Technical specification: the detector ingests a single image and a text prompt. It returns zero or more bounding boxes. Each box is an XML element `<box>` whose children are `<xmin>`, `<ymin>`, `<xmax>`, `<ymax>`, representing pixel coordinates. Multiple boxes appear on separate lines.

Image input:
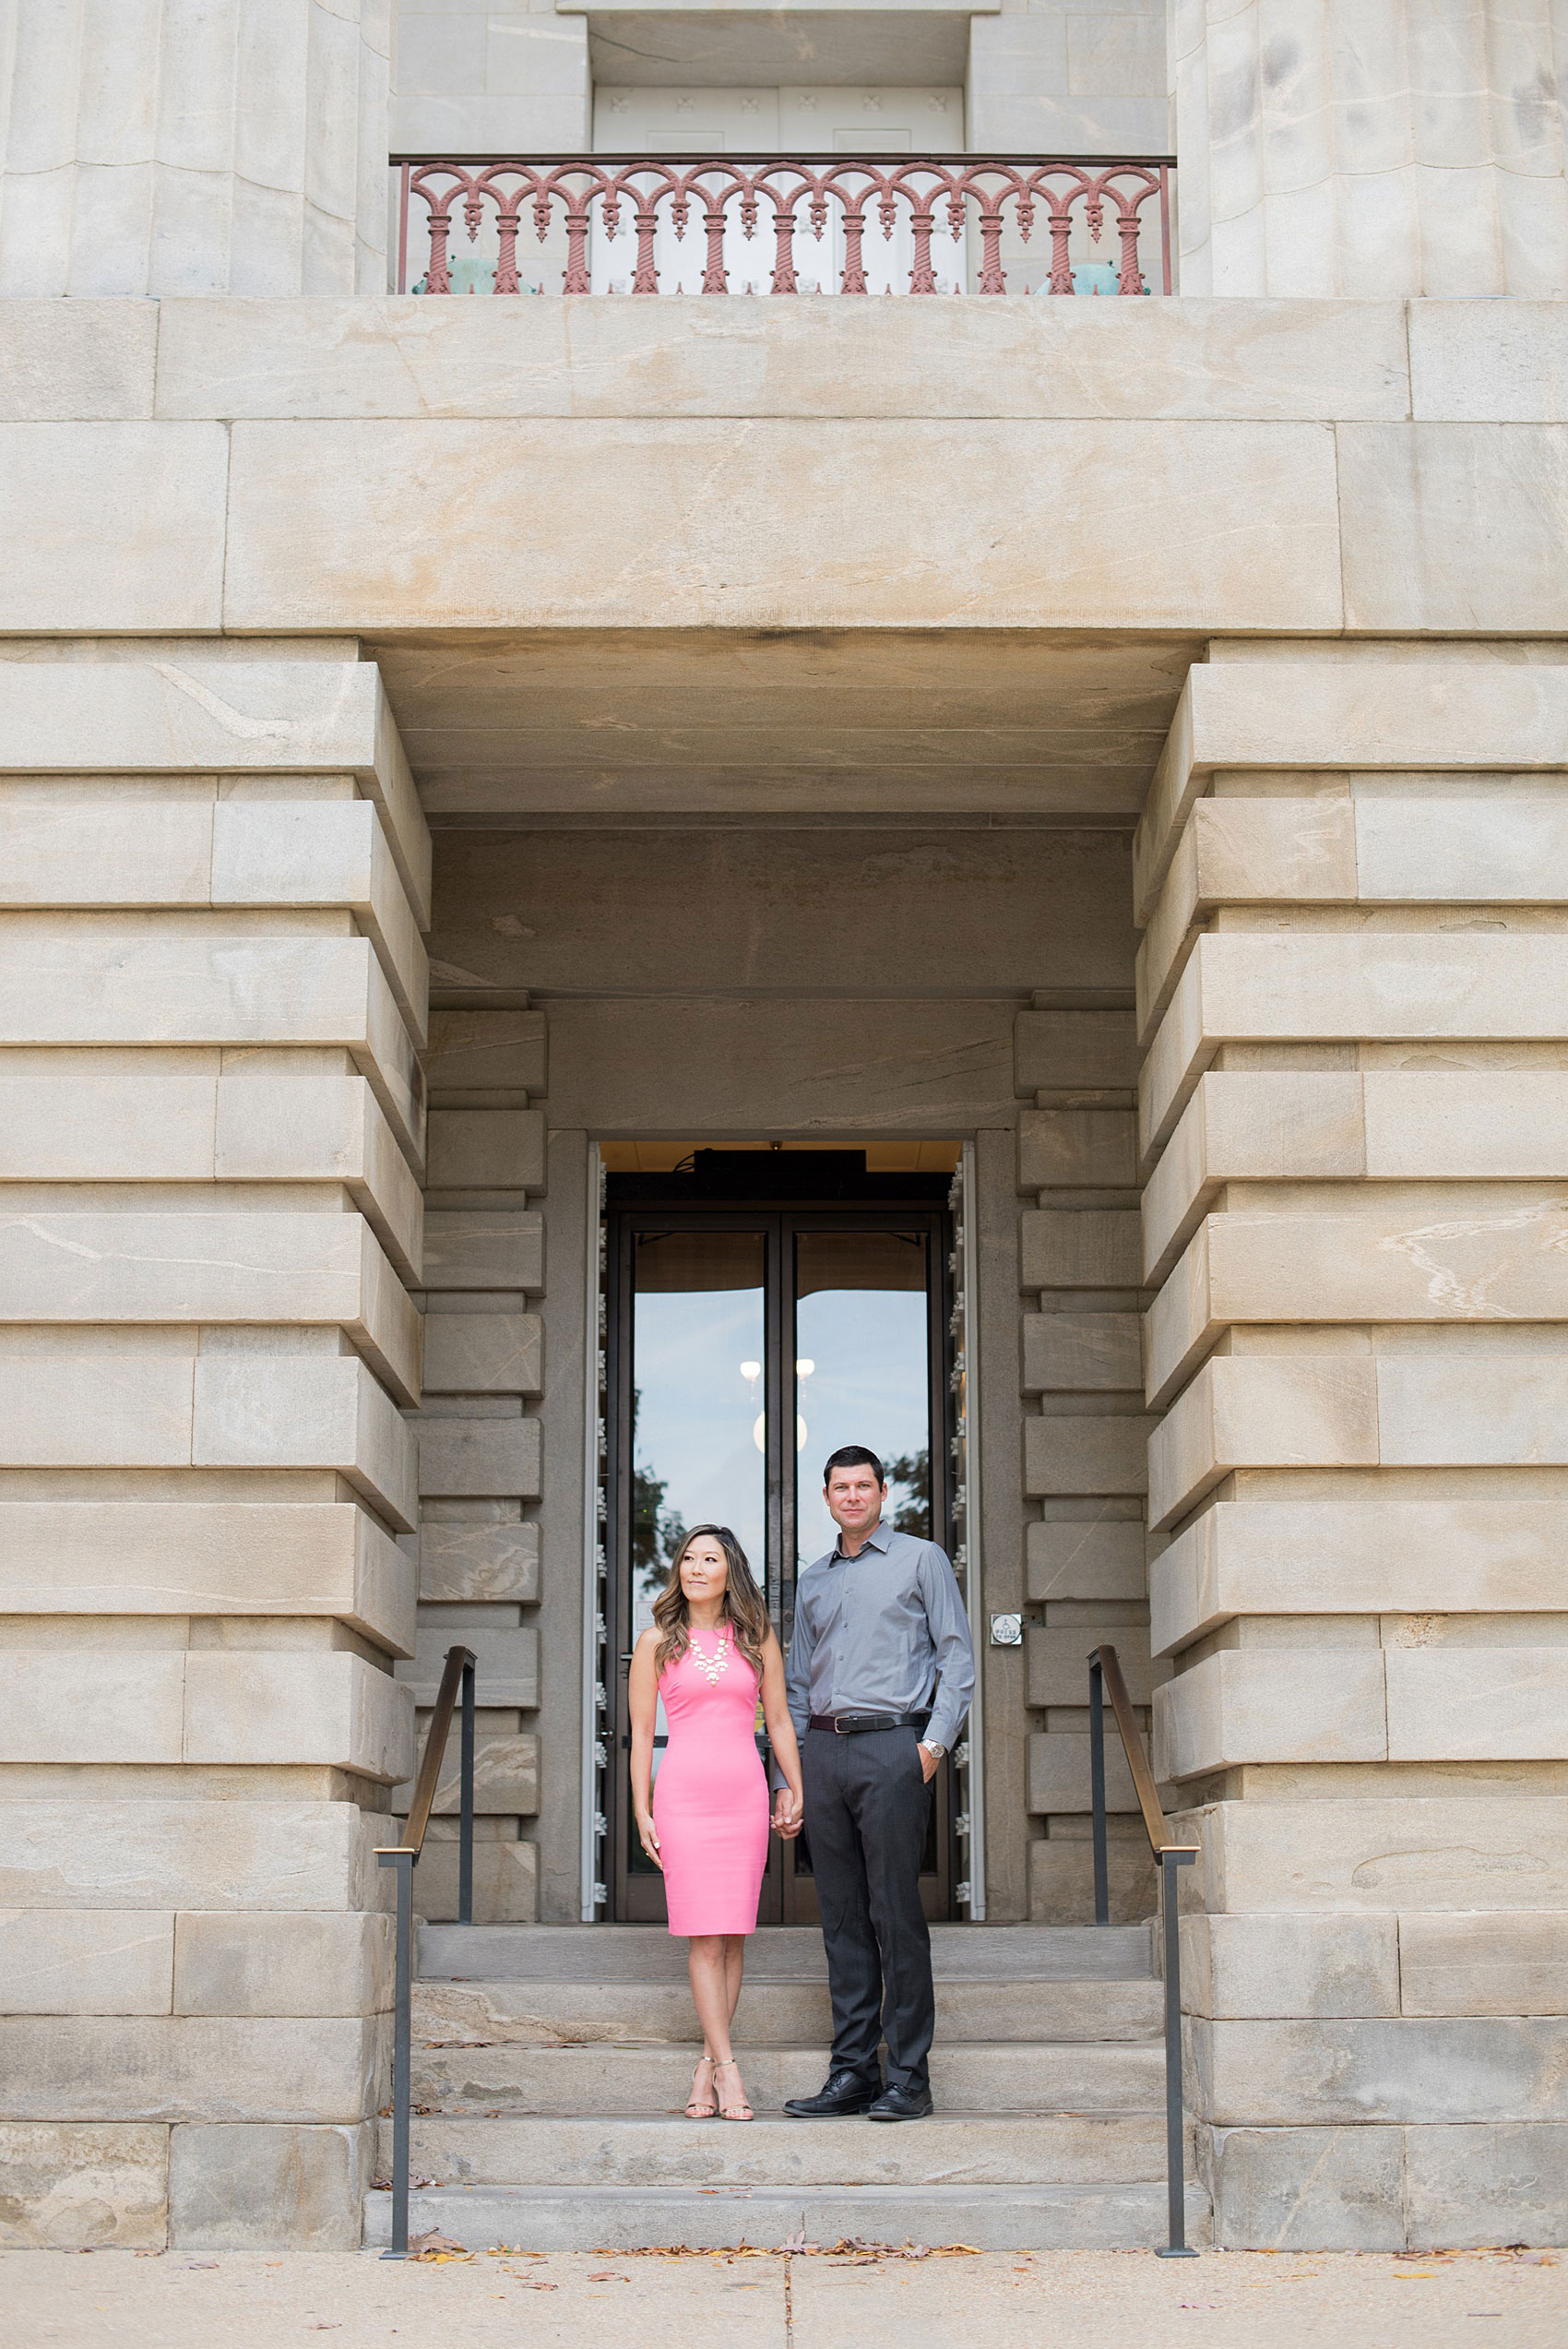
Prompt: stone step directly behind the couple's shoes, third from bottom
<box><xmin>413</xmin><ymin>2041</ymin><xmax>1164</xmax><ymax>2135</ymax></box>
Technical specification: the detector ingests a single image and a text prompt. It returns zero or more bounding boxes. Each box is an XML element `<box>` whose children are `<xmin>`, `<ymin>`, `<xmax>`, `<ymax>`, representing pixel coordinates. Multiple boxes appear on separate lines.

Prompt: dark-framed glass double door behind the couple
<box><xmin>608</xmin><ymin>1200</ymin><xmax>951</xmax><ymax>1924</ymax></box>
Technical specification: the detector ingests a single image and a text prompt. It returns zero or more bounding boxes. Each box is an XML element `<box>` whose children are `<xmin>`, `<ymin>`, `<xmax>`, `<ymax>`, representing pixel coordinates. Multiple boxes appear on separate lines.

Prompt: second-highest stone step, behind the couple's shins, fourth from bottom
<box><xmin>413</xmin><ymin>1978</ymin><xmax>1164</xmax><ymax>2048</ymax></box>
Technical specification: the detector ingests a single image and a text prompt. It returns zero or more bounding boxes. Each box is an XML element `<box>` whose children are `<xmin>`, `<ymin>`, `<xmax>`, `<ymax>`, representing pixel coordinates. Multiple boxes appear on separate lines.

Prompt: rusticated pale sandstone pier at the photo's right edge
<box><xmin>1136</xmin><ymin>644</ymin><xmax>1568</xmax><ymax>2248</ymax></box>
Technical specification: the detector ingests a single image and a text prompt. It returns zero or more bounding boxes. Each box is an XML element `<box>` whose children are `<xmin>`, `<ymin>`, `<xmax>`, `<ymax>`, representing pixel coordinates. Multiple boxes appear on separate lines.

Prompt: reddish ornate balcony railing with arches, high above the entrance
<box><xmin>392</xmin><ymin>155</ymin><xmax>1173</xmax><ymax>298</ymax></box>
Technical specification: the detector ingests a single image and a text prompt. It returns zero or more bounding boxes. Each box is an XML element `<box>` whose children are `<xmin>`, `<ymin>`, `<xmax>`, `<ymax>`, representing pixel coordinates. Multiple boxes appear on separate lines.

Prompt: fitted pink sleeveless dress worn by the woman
<box><xmin>652</xmin><ymin>1632</ymin><xmax>767</xmax><ymax>1933</ymax></box>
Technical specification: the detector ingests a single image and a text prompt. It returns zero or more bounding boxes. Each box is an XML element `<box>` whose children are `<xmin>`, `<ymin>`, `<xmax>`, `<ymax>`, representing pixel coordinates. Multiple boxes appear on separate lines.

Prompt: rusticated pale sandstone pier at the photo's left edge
<box><xmin>0</xmin><ymin>646</ymin><xmax>430</xmax><ymax>2248</ymax></box>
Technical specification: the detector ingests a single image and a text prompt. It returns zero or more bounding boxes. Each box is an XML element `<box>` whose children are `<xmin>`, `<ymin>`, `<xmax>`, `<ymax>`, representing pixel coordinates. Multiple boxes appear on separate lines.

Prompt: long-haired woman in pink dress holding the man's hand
<box><xmin>629</xmin><ymin>1524</ymin><xmax>802</xmax><ymax>2121</ymax></box>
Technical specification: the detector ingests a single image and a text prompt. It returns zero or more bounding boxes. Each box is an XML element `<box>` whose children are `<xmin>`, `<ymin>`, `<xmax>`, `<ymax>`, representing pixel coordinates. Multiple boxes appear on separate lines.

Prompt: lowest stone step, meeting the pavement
<box><xmin>366</xmin><ymin>2170</ymin><xmax>1209</xmax><ymax>2250</ymax></box>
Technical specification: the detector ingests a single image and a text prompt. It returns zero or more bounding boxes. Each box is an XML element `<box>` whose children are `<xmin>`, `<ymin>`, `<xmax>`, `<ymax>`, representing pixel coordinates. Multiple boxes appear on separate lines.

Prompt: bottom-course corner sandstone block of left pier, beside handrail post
<box><xmin>169</xmin><ymin>2121</ymin><xmax>374</xmax><ymax>2250</ymax></box>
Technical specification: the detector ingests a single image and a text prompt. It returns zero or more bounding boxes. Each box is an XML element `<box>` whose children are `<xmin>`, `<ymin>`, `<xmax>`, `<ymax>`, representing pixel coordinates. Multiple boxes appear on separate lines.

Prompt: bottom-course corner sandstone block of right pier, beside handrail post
<box><xmin>1211</xmin><ymin>2126</ymin><xmax>1404</xmax><ymax>2250</ymax></box>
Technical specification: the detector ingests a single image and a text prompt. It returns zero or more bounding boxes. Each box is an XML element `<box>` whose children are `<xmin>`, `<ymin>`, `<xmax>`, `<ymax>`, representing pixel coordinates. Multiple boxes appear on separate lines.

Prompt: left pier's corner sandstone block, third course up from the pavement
<box><xmin>173</xmin><ymin>1910</ymin><xmax>392</xmax><ymax>2015</ymax></box>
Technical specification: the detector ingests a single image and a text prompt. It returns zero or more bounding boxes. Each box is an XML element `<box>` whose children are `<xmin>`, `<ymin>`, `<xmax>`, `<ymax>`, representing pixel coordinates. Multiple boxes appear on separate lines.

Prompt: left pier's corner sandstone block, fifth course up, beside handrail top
<box><xmin>184</xmin><ymin>1649</ymin><xmax>413</xmax><ymax>1783</ymax></box>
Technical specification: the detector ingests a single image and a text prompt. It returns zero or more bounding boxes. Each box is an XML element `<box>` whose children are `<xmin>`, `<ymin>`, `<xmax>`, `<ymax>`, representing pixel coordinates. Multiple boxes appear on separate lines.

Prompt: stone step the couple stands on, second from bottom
<box><xmin>375</xmin><ymin>2109</ymin><xmax>1182</xmax><ymax>2189</ymax></box>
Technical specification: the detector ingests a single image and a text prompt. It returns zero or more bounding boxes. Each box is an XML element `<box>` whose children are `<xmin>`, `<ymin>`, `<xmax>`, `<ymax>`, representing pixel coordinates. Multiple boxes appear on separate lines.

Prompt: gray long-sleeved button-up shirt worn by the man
<box><xmin>784</xmin><ymin>1524</ymin><xmax>974</xmax><ymax>1746</ymax></box>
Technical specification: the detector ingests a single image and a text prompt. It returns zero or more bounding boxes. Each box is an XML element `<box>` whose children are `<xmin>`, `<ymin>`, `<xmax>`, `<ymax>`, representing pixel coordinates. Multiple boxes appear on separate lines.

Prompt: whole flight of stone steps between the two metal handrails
<box><xmin>366</xmin><ymin>1924</ymin><xmax>1209</xmax><ymax>2250</ymax></box>
